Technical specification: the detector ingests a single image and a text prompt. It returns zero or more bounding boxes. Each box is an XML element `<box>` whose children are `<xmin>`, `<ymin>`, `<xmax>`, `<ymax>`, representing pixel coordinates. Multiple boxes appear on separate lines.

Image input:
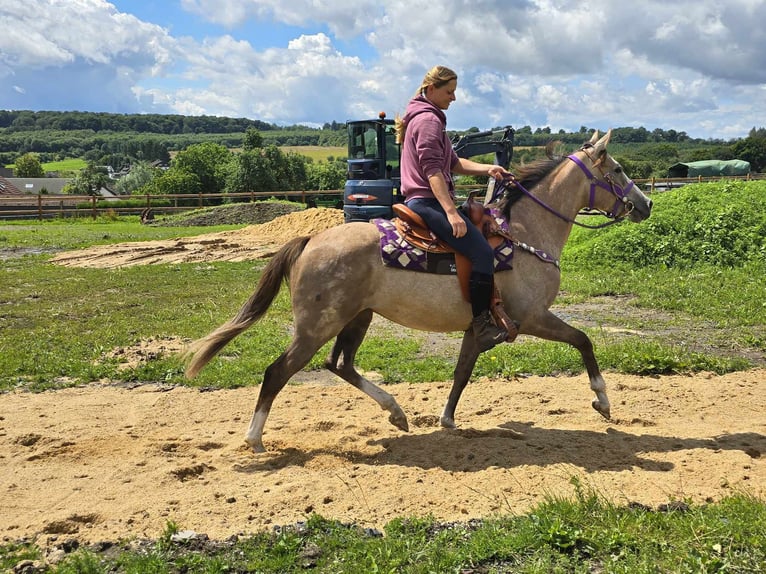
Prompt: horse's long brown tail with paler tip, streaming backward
<box><xmin>184</xmin><ymin>237</ymin><xmax>309</xmax><ymax>378</ymax></box>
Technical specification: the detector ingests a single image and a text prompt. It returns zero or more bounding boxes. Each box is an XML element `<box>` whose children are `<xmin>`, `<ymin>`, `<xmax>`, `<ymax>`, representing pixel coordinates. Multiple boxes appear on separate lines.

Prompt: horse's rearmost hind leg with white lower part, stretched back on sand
<box><xmin>245</xmin><ymin>335</ymin><xmax>325</xmax><ymax>452</ymax></box>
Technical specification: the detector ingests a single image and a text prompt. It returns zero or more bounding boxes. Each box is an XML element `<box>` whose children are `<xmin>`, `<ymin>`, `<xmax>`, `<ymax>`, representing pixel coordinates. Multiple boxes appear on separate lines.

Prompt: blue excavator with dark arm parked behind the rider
<box><xmin>343</xmin><ymin>112</ymin><xmax>514</xmax><ymax>223</ymax></box>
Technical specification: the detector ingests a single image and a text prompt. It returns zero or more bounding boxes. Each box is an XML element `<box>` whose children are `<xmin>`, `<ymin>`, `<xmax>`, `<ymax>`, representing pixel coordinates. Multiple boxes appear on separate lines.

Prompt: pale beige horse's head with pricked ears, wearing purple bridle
<box><xmin>568</xmin><ymin>129</ymin><xmax>652</xmax><ymax>222</ymax></box>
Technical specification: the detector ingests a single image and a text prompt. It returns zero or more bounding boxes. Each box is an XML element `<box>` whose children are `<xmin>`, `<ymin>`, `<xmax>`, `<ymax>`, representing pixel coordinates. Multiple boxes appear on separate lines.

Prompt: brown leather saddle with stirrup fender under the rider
<box><xmin>392</xmin><ymin>196</ymin><xmax>519</xmax><ymax>343</ymax></box>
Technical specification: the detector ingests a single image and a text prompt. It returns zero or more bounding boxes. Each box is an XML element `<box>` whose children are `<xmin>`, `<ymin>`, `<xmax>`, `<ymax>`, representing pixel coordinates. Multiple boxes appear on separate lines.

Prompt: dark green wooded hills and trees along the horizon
<box><xmin>0</xmin><ymin>110</ymin><xmax>766</xmax><ymax>196</ymax></box>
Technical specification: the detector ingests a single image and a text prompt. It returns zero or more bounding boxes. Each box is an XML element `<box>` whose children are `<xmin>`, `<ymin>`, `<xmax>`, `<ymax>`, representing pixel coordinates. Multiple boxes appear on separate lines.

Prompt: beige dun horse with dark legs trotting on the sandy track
<box><xmin>185</xmin><ymin>130</ymin><xmax>652</xmax><ymax>453</ymax></box>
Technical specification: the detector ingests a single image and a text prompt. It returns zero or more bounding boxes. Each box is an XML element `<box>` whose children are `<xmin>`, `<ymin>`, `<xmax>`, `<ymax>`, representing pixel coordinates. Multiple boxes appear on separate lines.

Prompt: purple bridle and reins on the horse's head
<box><xmin>494</xmin><ymin>143</ymin><xmax>635</xmax><ymax>229</ymax></box>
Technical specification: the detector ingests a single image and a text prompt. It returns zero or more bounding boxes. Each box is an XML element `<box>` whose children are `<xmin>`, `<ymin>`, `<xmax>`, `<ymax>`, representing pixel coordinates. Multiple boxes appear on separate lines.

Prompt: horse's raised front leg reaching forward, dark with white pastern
<box><xmin>522</xmin><ymin>311</ymin><xmax>611</xmax><ymax>419</ymax></box>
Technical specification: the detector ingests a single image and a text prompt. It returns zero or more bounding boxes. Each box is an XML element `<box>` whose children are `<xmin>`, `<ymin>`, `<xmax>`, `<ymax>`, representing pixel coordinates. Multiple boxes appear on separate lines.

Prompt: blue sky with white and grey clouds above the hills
<box><xmin>0</xmin><ymin>0</ymin><xmax>766</xmax><ymax>140</ymax></box>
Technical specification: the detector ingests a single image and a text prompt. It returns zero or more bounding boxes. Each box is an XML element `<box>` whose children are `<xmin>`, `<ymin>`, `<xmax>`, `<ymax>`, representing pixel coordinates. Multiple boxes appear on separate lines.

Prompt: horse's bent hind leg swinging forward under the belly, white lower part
<box><xmin>325</xmin><ymin>309</ymin><xmax>409</xmax><ymax>431</ymax></box>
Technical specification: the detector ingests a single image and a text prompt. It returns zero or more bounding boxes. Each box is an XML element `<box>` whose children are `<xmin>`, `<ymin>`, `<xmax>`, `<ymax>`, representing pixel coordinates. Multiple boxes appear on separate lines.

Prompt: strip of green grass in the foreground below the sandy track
<box><xmin>0</xmin><ymin>492</ymin><xmax>766</xmax><ymax>574</ymax></box>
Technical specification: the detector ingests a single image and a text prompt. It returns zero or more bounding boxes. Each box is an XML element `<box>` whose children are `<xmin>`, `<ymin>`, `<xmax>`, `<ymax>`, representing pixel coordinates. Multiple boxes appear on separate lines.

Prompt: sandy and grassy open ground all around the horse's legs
<box><xmin>0</xmin><ymin>183</ymin><xmax>766</xmax><ymax>572</ymax></box>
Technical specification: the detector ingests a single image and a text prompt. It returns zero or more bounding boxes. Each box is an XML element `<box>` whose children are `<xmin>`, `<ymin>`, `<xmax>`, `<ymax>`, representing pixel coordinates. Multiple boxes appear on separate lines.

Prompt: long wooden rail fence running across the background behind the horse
<box><xmin>0</xmin><ymin>173</ymin><xmax>766</xmax><ymax>220</ymax></box>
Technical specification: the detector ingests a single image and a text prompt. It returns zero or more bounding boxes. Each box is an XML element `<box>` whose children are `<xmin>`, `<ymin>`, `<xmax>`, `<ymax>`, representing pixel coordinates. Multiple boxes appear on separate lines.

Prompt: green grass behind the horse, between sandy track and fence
<box><xmin>0</xmin><ymin>182</ymin><xmax>766</xmax><ymax>389</ymax></box>
